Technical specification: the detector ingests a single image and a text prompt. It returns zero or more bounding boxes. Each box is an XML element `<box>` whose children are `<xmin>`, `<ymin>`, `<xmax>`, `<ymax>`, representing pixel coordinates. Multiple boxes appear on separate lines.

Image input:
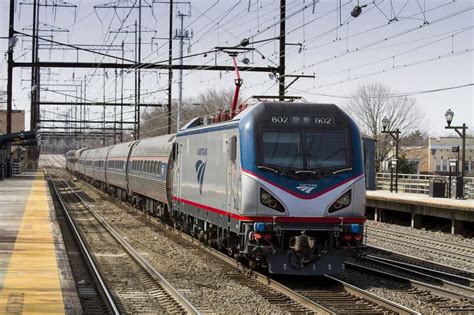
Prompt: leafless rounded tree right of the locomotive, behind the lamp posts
<box><xmin>344</xmin><ymin>83</ymin><xmax>425</xmax><ymax>169</ymax></box>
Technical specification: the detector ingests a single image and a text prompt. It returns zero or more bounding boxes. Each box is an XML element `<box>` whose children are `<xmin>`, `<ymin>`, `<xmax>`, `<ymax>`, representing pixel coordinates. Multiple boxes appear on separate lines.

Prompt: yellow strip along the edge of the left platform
<box><xmin>0</xmin><ymin>172</ymin><xmax>64</xmax><ymax>314</ymax></box>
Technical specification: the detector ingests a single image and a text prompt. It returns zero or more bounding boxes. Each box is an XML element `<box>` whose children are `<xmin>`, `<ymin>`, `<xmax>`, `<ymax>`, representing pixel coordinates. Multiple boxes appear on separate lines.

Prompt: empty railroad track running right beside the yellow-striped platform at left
<box><xmin>46</xmin><ymin>170</ymin><xmax>200</xmax><ymax>314</ymax></box>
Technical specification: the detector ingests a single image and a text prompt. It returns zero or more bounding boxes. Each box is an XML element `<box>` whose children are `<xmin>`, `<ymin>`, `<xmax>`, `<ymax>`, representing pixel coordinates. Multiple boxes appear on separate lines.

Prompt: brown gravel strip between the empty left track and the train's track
<box><xmin>71</xmin><ymin>182</ymin><xmax>284</xmax><ymax>314</ymax></box>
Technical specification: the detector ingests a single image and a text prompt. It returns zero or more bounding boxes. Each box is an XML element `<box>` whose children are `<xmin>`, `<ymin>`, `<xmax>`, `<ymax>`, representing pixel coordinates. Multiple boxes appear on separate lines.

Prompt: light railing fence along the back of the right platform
<box><xmin>377</xmin><ymin>173</ymin><xmax>474</xmax><ymax>199</ymax></box>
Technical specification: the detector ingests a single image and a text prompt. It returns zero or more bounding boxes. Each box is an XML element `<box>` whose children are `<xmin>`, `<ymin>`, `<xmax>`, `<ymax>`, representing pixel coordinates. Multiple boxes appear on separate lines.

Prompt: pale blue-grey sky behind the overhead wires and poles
<box><xmin>0</xmin><ymin>0</ymin><xmax>474</xmax><ymax>136</ymax></box>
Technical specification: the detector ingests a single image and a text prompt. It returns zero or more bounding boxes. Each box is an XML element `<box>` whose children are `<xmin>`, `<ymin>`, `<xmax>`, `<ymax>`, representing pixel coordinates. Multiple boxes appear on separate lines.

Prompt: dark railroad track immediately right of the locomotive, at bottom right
<box><xmin>346</xmin><ymin>259</ymin><xmax>474</xmax><ymax>314</ymax></box>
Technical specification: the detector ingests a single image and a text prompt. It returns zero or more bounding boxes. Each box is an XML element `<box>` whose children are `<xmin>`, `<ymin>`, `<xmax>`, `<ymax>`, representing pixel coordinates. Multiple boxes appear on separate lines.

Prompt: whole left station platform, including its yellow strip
<box><xmin>0</xmin><ymin>171</ymin><xmax>81</xmax><ymax>314</ymax></box>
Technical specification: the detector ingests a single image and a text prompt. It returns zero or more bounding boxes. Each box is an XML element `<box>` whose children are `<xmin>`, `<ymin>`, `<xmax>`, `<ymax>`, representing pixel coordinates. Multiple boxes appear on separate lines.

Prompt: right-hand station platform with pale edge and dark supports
<box><xmin>367</xmin><ymin>190</ymin><xmax>474</xmax><ymax>234</ymax></box>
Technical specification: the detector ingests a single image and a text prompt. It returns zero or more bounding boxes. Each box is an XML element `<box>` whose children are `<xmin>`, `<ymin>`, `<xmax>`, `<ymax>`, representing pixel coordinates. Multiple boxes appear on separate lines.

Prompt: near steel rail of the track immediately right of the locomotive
<box><xmin>346</xmin><ymin>262</ymin><xmax>474</xmax><ymax>301</ymax></box>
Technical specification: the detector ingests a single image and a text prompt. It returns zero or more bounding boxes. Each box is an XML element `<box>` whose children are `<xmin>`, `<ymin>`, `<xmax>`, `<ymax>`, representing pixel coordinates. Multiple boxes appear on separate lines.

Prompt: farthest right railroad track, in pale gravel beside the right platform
<box><xmin>367</xmin><ymin>227</ymin><xmax>474</xmax><ymax>263</ymax></box>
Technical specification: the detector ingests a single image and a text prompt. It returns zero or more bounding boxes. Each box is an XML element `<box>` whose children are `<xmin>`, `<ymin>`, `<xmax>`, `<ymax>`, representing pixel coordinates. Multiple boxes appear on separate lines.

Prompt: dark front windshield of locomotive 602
<box><xmin>260</xmin><ymin>131</ymin><xmax>350</xmax><ymax>171</ymax></box>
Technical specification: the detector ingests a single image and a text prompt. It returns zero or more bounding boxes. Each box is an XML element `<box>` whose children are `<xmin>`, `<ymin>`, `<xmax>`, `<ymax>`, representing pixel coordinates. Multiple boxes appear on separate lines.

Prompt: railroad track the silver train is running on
<box><xmin>50</xmin><ymin>167</ymin><xmax>417</xmax><ymax>314</ymax></box>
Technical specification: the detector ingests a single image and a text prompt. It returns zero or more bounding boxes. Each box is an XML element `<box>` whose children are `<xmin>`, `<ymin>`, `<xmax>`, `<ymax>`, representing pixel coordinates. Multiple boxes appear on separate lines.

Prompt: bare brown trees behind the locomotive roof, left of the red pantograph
<box><xmin>140</xmin><ymin>89</ymin><xmax>241</xmax><ymax>138</ymax></box>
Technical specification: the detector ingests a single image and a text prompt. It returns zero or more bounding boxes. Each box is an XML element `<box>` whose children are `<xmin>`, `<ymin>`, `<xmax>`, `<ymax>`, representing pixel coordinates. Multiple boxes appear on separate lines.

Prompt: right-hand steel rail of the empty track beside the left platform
<box><xmin>61</xmin><ymin>179</ymin><xmax>201</xmax><ymax>314</ymax></box>
